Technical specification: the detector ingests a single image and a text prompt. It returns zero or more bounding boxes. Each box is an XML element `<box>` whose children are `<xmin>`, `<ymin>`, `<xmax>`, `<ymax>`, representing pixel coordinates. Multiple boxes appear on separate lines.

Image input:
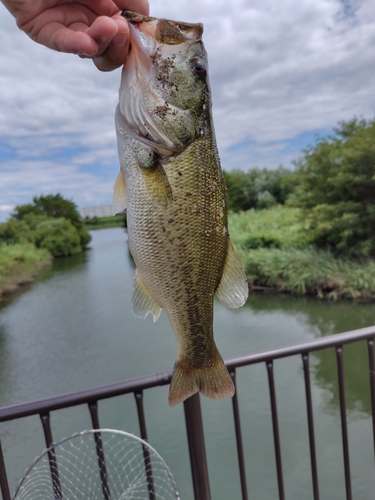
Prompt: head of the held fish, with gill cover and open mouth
<box><xmin>118</xmin><ymin>11</ymin><xmax>210</xmax><ymax>156</ymax></box>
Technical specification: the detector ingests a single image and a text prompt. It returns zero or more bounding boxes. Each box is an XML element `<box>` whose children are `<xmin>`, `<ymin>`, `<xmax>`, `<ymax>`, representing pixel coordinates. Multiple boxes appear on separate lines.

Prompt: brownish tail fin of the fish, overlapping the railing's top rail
<box><xmin>168</xmin><ymin>346</ymin><xmax>235</xmax><ymax>406</ymax></box>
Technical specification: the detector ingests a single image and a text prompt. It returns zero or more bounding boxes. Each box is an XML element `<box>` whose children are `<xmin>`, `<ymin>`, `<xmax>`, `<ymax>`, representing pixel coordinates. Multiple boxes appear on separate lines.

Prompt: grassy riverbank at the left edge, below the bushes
<box><xmin>0</xmin><ymin>243</ymin><xmax>53</xmax><ymax>301</ymax></box>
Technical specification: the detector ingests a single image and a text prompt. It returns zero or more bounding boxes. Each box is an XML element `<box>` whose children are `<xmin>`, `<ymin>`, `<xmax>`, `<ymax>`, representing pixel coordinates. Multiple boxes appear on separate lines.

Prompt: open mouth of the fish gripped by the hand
<box><xmin>122</xmin><ymin>10</ymin><xmax>203</xmax><ymax>45</ymax></box>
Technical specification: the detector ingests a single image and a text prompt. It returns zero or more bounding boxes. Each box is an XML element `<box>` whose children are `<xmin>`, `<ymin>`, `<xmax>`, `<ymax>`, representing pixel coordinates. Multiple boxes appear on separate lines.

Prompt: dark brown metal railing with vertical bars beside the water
<box><xmin>0</xmin><ymin>327</ymin><xmax>375</xmax><ymax>500</ymax></box>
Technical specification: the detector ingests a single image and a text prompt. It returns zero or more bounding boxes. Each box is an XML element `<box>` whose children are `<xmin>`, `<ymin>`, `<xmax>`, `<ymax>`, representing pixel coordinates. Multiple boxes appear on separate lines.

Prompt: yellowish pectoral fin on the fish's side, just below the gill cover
<box><xmin>140</xmin><ymin>156</ymin><xmax>173</xmax><ymax>207</ymax></box>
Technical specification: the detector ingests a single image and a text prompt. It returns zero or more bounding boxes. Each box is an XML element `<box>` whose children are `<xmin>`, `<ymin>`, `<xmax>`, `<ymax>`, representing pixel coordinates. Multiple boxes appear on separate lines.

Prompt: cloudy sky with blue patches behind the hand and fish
<box><xmin>0</xmin><ymin>0</ymin><xmax>375</xmax><ymax>221</ymax></box>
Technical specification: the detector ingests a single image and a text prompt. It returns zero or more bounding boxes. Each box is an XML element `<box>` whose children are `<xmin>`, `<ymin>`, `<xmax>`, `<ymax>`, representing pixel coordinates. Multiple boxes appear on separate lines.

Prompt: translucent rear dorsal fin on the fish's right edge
<box><xmin>216</xmin><ymin>240</ymin><xmax>249</xmax><ymax>309</ymax></box>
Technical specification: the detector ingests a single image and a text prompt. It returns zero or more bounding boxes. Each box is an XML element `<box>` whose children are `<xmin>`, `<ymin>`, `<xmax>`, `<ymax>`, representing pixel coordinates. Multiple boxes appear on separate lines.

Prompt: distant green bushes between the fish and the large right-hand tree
<box><xmin>224</xmin><ymin>166</ymin><xmax>292</xmax><ymax>212</ymax></box>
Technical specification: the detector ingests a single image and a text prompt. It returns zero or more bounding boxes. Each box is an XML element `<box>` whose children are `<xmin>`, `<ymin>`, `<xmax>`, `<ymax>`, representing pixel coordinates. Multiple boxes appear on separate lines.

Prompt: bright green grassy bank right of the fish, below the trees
<box><xmin>229</xmin><ymin>207</ymin><xmax>375</xmax><ymax>300</ymax></box>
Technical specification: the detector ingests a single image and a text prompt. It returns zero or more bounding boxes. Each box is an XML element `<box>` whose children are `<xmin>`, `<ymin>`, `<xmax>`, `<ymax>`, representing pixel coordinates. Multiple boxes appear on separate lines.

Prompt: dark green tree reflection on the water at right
<box><xmin>247</xmin><ymin>292</ymin><xmax>375</xmax><ymax>419</ymax></box>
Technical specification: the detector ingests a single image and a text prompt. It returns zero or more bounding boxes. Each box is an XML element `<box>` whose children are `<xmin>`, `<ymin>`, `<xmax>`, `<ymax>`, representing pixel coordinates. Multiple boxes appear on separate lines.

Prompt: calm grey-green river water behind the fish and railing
<box><xmin>0</xmin><ymin>228</ymin><xmax>375</xmax><ymax>500</ymax></box>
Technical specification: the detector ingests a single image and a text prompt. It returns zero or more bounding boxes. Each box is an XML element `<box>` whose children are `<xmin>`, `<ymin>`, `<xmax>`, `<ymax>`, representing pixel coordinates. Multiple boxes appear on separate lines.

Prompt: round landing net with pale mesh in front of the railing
<box><xmin>13</xmin><ymin>429</ymin><xmax>180</xmax><ymax>500</ymax></box>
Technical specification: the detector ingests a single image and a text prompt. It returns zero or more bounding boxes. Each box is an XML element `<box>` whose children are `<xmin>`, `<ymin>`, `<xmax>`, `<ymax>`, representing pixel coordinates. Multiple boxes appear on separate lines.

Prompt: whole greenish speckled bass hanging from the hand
<box><xmin>113</xmin><ymin>11</ymin><xmax>249</xmax><ymax>406</ymax></box>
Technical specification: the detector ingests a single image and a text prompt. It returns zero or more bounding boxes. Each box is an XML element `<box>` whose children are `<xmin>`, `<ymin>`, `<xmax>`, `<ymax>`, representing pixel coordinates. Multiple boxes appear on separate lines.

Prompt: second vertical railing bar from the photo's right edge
<box><xmin>336</xmin><ymin>345</ymin><xmax>352</xmax><ymax>500</ymax></box>
